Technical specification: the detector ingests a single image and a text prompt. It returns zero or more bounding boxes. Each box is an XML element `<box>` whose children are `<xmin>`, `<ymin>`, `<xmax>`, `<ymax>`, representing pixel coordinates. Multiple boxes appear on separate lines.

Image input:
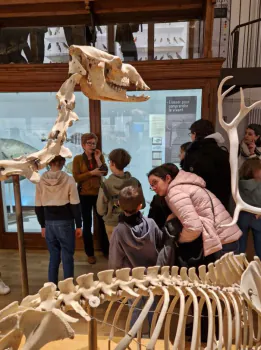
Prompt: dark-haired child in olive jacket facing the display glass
<box><xmin>97</xmin><ymin>148</ymin><xmax>145</xmax><ymax>240</ymax></box>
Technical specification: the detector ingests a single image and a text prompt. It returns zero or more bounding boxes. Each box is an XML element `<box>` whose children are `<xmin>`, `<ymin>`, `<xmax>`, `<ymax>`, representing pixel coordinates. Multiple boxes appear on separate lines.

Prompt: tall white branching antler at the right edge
<box><xmin>217</xmin><ymin>76</ymin><xmax>261</xmax><ymax>226</ymax></box>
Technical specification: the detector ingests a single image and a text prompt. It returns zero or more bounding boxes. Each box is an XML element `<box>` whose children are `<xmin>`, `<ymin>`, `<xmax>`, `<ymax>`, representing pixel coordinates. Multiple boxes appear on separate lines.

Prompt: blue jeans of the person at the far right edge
<box><xmin>237</xmin><ymin>211</ymin><xmax>261</xmax><ymax>259</ymax></box>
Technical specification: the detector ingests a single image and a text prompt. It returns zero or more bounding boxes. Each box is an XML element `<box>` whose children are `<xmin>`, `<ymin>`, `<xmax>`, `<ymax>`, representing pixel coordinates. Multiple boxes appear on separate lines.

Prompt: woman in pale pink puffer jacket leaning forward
<box><xmin>148</xmin><ymin>166</ymin><xmax>242</xmax><ymax>264</ymax></box>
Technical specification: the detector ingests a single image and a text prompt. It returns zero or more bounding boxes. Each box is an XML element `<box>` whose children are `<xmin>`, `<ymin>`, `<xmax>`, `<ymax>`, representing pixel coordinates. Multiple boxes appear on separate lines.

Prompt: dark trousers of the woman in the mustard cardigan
<box><xmin>80</xmin><ymin>195</ymin><xmax>109</xmax><ymax>256</ymax></box>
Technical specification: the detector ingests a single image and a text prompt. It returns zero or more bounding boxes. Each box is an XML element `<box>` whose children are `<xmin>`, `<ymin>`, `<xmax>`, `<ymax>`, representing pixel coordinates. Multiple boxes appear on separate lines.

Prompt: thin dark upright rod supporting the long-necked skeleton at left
<box><xmin>12</xmin><ymin>175</ymin><xmax>29</xmax><ymax>298</ymax></box>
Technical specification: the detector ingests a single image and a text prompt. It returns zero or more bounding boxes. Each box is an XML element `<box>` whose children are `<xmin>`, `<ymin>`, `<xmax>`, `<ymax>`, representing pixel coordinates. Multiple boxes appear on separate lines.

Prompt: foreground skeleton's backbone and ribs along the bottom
<box><xmin>0</xmin><ymin>253</ymin><xmax>261</xmax><ymax>350</ymax></box>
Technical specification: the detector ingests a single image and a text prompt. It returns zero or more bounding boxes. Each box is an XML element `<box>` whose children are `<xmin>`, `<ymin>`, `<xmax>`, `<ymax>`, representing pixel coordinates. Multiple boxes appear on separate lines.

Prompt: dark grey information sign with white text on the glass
<box><xmin>165</xmin><ymin>96</ymin><xmax>197</xmax><ymax>163</ymax></box>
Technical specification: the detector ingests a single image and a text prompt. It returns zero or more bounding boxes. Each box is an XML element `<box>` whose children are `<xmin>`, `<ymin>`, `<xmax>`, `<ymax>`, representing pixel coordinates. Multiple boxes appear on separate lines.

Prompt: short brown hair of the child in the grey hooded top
<box><xmin>119</xmin><ymin>186</ymin><xmax>143</xmax><ymax>215</ymax></box>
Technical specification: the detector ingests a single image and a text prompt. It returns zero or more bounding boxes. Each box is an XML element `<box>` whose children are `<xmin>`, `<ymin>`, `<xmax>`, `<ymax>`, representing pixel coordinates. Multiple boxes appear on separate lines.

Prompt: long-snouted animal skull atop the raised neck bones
<box><xmin>69</xmin><ymin>45</ymin><xmax>150</xmax><ymax>102</ymax></box>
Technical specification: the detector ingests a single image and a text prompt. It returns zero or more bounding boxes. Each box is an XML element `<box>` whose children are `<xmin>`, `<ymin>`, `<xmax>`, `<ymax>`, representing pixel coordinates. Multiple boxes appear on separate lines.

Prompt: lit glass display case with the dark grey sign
<box><xmin>101</xmin><ymin>89</ymin><xmax>202</xmax><ymax>215</ymax></box>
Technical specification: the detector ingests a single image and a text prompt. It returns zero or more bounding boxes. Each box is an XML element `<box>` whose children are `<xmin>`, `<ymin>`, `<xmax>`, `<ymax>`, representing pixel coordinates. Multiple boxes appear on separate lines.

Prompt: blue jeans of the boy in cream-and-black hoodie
<box><xmin>45</xmin><ymin>220</ymin><xmax>75</xmax><ymax>285</ymax></box>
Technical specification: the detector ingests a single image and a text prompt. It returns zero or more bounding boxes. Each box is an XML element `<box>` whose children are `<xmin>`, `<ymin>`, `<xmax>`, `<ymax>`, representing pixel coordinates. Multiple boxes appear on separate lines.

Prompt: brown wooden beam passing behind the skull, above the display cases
<box><xmin>0</xmin><ymin>58</ymin><xmax>224</xmax><ymax>94</ymax></box>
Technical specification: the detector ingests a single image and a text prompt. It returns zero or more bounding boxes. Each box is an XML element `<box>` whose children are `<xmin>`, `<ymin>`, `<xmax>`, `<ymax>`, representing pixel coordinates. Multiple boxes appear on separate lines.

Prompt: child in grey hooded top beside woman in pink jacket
<box><xmin>109</xmin><ymin>186</ymin><xmax>162</xmax><ymax>270</ymax></box>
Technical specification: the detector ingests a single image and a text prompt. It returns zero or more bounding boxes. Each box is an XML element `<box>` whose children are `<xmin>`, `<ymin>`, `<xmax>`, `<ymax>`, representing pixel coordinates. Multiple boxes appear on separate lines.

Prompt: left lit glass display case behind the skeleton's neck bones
<box><xmin>0</xmin><ymin>92</ymin><xmax>90</xmax><ymax>232</ymax></box>
